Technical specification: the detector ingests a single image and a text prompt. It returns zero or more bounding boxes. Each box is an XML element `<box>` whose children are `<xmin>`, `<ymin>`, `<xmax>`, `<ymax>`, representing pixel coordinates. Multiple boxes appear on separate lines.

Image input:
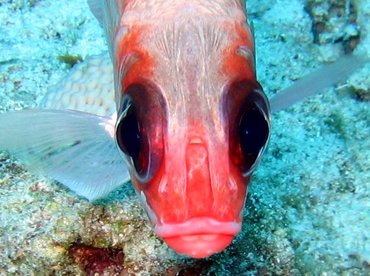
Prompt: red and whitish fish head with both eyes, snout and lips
<box><xmin>115</xmin><ymin>10</ymin><xmax>270</xmax><ymax>258</ymax></box>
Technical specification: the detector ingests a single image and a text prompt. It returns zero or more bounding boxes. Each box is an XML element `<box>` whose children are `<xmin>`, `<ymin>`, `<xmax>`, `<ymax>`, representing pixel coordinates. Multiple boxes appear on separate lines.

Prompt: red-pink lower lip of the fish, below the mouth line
<box><xmin>164</xmin><ymin>234</ymin><xmax>234</xmax><ymax>259</ymax></box>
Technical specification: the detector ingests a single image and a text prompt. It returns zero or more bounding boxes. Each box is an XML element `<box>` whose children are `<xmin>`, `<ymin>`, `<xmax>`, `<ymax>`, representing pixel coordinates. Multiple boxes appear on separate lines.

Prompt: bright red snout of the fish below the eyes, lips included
<box><xmin>134</xmin><ymin>135</ymin><xmax>249</xmax><ymax>258</ymax></box>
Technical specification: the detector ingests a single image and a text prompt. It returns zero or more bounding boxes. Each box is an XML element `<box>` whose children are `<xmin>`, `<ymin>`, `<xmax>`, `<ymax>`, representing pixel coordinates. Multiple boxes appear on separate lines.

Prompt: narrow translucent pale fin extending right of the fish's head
<box><xmin>270</xmin><ymin>55</ymin><xmax>367</xmax><ymax>111</ymax></box>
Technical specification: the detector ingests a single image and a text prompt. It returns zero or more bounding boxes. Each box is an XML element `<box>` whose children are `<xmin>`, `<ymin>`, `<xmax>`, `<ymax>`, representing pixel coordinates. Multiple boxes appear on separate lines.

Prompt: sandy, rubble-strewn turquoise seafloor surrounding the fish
<box><xmin>0</xmin><ymin>0</ymin><xmax>370</xmax><ymax>275</ymax></box>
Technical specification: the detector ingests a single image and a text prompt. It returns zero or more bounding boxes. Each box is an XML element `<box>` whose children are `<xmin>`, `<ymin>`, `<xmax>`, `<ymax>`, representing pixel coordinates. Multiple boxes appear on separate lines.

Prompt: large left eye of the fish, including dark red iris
<box><xmin>116</xmin><ymin>83</ymin><xmax>166</xmax><ymax>184</ymax></box>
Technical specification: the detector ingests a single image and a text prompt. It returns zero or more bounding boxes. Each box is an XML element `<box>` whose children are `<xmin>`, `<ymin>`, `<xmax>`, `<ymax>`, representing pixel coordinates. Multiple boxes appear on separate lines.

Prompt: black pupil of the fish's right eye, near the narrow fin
<box><xmin>239</xmin><ymin>102</ymin><xmax>269</xmax><ymax>167</ymax></box>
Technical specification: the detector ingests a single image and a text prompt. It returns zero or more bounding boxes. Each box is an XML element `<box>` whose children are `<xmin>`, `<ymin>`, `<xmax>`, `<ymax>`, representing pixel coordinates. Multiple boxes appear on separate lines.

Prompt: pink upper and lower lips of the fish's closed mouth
<box><xmin>154</xmin><ymin>217</ymin><xmax>241</xmax><ymax>258</ymax></box>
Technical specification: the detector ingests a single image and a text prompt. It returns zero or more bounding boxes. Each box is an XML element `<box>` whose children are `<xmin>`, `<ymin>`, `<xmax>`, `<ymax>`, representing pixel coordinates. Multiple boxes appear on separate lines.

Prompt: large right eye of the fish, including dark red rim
<box><xmin>222</xmin><ymin>80</ymin><xmax>270</xmax><ymax>176</ymax></box>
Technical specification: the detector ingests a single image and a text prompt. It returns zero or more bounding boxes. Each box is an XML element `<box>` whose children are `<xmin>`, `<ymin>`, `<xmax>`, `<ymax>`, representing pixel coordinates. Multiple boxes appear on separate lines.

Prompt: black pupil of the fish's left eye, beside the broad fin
<box><xmin>116</xmin><ymin>102</ymin><xmax>141</xmax><ymax>163</ymax></box>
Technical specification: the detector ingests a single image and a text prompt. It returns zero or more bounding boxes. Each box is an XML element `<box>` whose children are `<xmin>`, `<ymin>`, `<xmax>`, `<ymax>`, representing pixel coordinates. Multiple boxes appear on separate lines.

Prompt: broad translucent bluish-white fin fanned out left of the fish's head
<box><xmin>0</xmin><ymin>110</ymin><xmax>129</xmax><ymax>200</ymax></box>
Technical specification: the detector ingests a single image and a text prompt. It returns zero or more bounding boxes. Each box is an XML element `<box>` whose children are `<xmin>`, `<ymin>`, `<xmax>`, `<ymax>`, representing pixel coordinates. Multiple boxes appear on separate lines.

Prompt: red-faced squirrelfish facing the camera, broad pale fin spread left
<box><xmin>0</xmin><ymin>0</ymin><xmax>364</xmax><ymax>258</ymax></box>
